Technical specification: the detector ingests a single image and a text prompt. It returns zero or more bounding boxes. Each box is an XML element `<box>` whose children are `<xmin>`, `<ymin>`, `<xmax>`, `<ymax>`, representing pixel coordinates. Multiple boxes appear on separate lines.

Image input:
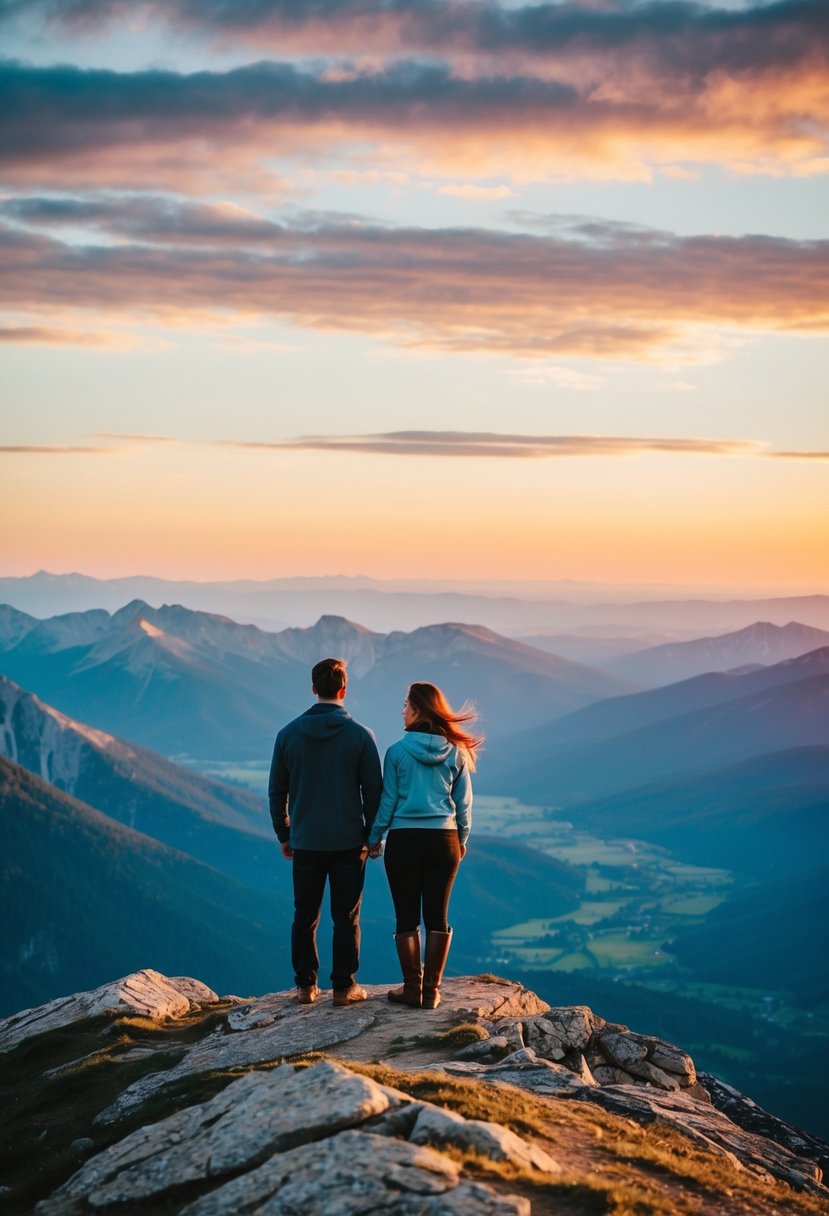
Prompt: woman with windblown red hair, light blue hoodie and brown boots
<box><xmin>368</xmin><ymin>683</ymin><xmax>484</xmax><ymax>1009</ymax></box>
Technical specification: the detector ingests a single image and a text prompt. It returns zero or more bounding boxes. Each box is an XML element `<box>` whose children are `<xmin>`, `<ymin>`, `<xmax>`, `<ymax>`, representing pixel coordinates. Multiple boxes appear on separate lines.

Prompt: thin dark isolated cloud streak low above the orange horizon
<box><xmin>216</xmin><ymin>430</ymin><xmax>767</xmax><ymax>460</ymax></box>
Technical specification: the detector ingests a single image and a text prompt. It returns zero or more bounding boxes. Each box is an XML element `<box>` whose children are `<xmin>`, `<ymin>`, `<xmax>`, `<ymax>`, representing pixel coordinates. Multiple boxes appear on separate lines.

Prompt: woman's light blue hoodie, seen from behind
<box><xmin>368</xmin><ymin>731</ymin><xmax>472</xmax><ymax>848</ymax></box>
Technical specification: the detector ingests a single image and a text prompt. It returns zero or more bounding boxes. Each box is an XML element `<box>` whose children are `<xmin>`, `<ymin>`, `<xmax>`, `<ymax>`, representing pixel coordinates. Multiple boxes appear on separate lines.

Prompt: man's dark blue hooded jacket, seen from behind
<box><xmin>267</xmin><ymin>704</ymin><xmax>383</xmax><ymax>850</ymax></box>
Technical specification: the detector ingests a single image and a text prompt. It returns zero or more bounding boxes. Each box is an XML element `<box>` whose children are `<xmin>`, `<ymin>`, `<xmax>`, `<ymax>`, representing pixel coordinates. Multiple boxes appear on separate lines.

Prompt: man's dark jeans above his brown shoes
<box><xmin>291</xmin><ymin>846</ymin><xmax>366</xmax><ymax>991</ymax></box>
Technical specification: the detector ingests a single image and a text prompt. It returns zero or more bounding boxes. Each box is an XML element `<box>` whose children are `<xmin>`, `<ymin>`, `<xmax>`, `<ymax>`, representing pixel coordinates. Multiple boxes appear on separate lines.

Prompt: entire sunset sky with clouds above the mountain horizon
<box><xmin>0</xmin><ymin>0</ymin><xmax>829</xmax><ymax>592</ymax></box>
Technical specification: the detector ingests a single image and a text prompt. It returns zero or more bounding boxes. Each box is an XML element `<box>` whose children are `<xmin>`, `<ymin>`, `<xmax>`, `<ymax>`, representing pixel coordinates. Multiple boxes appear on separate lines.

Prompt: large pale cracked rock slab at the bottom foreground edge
<box><xmin>36</xmin><ymin>1062</ymin><xmax>534</xmax><ymax>1216</ymax></box>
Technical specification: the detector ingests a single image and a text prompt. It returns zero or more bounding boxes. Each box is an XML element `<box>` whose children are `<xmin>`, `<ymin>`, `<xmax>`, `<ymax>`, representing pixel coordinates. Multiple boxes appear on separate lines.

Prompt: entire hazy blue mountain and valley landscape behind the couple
<box><xmin>0</xmin><ymin>591</ymin><xmax>829</xmax><ymax>1133</ymax></box>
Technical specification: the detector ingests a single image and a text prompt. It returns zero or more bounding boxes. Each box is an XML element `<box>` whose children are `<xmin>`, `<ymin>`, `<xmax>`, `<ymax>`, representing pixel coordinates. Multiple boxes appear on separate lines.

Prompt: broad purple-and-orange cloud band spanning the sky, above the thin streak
<box><xmin>0</xmin><ymin>197</ymin><xmax>829</xmax><ymax>357</ymax></box>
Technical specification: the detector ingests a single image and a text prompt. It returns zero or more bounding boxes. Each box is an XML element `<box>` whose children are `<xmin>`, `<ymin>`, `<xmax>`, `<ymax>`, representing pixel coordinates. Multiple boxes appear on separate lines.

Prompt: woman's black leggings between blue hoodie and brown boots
<box><xmin>384</xmin><ymin>828</ymin><xmax>461</xmax><ymax>933</ymax></box>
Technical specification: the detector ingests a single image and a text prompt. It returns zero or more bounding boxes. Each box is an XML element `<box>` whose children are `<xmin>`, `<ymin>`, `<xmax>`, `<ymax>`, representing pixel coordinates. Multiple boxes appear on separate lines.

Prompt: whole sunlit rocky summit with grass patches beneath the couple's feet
<box><xmin>0</xmin><ymin>972</ymin><xmax>829</xmax><ymax>1216</ymax></box>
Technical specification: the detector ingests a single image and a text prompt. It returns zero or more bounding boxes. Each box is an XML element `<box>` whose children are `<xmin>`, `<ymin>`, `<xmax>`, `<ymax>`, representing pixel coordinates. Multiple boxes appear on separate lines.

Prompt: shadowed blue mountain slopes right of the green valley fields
<box><xmin>480</xmin><ymin>647</ymin><xmax>829</xmax><ymax>1026</ymax></box>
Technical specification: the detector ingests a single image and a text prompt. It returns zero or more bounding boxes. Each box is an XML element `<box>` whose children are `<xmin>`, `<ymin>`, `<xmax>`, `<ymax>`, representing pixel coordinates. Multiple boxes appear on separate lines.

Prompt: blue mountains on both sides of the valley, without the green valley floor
<box><xmin>0</xmin><ymin>602</ymin><xmax>829</xmax><ymax>1143</ymax></box>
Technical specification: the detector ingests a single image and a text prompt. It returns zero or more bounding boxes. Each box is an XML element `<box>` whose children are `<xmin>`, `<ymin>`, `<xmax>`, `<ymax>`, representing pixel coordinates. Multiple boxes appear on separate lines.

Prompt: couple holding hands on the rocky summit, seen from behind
<box><xmin>269</xmin><ymin>659</ymin><xmax>483</xmax><ymax>1009</ymax></box>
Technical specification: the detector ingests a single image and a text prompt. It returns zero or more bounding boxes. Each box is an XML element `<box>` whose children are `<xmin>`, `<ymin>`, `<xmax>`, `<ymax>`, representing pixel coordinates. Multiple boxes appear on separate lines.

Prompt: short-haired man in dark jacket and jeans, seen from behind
<box><xmin>267</xmin><ymin>659</ymin><xmax>383</xmax><ymax>1006</ymax></box>
